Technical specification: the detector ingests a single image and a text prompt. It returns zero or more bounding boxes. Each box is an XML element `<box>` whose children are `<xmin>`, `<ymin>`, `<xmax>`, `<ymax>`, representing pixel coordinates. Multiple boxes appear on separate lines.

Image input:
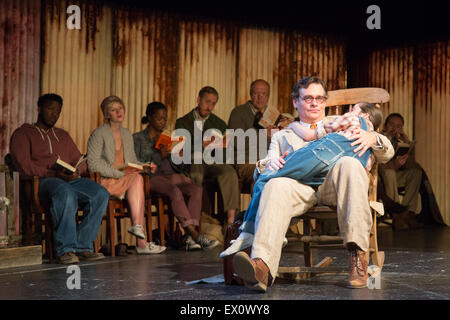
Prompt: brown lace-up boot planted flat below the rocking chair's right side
<box><xmin>347</xmin><ymin>246</ymin><xmax>369</xmax><ymax>289</ymax></box>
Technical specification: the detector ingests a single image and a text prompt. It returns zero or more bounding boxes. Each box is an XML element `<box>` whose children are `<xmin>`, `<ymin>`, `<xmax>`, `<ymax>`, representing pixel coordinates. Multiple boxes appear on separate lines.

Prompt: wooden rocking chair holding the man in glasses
<box><xmin>277</xmin><ymin>88</ymin><xmax>389</xmax><ymax>280</ymax></box>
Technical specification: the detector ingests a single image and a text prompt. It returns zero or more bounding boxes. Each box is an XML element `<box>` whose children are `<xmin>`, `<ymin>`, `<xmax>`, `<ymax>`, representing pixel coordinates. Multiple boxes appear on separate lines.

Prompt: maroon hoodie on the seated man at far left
<box><xmin>10</xmin><ymin>123</ymin><xmax>87</xmax><ymax>178</ymax></box>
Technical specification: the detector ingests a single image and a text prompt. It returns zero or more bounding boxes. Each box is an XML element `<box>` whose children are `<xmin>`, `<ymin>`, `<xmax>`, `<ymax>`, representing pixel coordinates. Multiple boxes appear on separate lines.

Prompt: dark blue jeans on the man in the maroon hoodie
<box><xmin>39</xmin><ymin>178</ymin><xmax>109</xmax><ymax>256</ymax></box>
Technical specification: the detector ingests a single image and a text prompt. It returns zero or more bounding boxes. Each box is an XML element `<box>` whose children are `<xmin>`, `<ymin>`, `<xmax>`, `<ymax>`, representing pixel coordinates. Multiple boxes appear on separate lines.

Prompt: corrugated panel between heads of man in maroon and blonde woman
<box><xmin>41</xmin><ymin>0</ymin><xmax>112</xmax><ymax>152</ymax></box>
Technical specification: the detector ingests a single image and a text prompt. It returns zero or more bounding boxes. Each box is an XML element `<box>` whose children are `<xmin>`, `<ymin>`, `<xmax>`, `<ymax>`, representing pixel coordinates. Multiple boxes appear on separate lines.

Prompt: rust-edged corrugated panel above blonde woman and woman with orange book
<box><xmin>111</xmin><ymin>7</ymin><xmax>178</xmax><ymax>132</ymax></box>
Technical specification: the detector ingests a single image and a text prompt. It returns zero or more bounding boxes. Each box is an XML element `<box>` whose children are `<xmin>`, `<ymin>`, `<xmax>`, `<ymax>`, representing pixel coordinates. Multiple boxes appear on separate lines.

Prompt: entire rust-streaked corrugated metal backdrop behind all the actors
<box><xmin>0</xmin><ymin>0</ymin><xmax>450</xmax><ymax>223</ymax></box>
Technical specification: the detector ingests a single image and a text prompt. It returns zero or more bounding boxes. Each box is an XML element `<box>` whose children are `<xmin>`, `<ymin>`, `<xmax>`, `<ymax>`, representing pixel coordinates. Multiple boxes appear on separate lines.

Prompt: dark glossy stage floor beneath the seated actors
<box><xmin>0</xmin><ymin>225</ymin><xmax>450</xmax><ymax>300</ymax></box>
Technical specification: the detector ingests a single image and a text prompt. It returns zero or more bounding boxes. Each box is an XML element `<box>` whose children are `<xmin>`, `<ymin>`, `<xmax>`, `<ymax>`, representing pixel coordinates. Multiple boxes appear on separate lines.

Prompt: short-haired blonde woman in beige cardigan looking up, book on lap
<box><xmin>87</xmin><ymin>96</ymin><xmax>166</xmax><ymax>254</ymax></box>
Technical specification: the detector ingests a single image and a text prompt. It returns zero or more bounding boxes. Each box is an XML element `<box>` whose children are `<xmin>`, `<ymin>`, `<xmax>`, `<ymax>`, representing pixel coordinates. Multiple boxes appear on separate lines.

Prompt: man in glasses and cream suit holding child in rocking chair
<box><xmin>233</xmin><ymin>77</ymin><xmax>394</xmax><ymax>292</ymax></box>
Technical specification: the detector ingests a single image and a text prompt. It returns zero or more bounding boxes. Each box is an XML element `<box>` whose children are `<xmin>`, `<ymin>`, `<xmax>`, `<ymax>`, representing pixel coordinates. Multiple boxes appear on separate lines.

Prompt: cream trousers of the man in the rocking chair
<box><xmin>251</xmin><ymin>157</ymin><xmax>372</xmax><ymax>279</ymax></box>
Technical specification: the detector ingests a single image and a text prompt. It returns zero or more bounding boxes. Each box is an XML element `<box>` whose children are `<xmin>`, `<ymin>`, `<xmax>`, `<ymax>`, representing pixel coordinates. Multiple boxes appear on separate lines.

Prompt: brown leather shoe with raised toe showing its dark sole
<box><xmin>233</xmin><ymin>251</ymin><xmax>273</xmax><ymax>292</ymax></box>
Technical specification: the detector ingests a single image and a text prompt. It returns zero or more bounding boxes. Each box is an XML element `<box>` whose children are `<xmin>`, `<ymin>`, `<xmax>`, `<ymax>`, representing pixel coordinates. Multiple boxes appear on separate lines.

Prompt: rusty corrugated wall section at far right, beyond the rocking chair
<box><xmin>351</xmin><ymin>41</ymin><xmax>450</xmax><ymax>224</ymax></box>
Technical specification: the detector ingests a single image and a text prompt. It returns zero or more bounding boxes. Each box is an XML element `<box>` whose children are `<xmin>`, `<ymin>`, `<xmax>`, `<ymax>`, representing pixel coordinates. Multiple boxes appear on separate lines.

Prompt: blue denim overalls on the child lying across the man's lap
<box><xmin>240</xmin><ymin>133</ymin><xmax>372</xmax><ymax>234</ymax></box>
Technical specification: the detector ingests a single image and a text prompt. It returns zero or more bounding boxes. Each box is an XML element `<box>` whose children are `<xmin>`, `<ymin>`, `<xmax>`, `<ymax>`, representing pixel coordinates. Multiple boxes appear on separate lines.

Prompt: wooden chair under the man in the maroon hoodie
<box><xmin>5</xmin><ymin>154</ymin><xmax>99</xmax><ymax>263</ymax></box>
